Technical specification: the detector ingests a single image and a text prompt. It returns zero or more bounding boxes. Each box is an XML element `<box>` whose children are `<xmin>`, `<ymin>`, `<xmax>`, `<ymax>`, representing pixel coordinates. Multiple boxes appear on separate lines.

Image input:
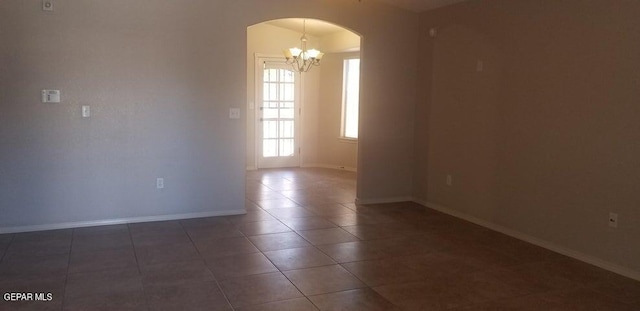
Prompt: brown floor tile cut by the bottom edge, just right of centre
<box><xmin>309</xmin><ymin>288</ymin><xmax>398</xmax><ymax>311</ymax></box>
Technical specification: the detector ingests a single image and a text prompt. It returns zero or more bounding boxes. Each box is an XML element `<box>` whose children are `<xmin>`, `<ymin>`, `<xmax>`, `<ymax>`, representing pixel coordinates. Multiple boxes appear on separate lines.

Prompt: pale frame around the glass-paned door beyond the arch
<box><xmin>252</xmin><ymin>53</ymin><xmax>304</xmax><ymax>169</ymax></box>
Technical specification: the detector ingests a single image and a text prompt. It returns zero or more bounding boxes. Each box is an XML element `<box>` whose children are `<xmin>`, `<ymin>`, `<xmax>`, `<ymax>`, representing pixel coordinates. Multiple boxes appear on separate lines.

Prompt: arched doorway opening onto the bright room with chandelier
<box><xmin>246</xmin><ymin>18</ymin><xmax>360</xmax><ymax>171</ymax></box>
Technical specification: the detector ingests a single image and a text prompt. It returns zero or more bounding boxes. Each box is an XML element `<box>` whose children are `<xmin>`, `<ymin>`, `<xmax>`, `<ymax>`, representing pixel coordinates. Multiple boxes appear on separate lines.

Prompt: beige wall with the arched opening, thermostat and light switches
<box><xmin>0</xmin><ymin>0</ymin><xmax>418</xmax><ymax>231</ymax></box>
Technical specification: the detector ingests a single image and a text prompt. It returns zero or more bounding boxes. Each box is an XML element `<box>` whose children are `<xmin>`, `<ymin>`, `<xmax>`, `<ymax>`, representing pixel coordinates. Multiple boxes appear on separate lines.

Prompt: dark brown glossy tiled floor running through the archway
<box><xmin>0</xmin><ymin>169</ymin><xmax>640</xmax><ymax>311</ymax></box>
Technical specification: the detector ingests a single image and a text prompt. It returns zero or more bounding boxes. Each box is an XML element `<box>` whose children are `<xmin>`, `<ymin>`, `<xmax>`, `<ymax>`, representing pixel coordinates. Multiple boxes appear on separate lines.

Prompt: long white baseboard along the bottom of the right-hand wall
<box><xmin>413</xmin><ymin>198</ymin><xmax>640</xmax><ymax>281</ymax></box>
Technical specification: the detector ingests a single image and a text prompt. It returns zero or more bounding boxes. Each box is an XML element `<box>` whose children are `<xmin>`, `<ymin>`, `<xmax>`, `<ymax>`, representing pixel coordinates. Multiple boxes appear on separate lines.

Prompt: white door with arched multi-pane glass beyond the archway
<box><xmin>257</xmin><ymin>61</ymin><xmax>300</xmax><ymax>168</ymax></box>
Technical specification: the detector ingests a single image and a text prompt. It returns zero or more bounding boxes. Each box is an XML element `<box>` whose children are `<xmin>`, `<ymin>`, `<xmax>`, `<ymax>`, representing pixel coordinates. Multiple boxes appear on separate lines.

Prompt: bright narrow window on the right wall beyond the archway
<box><xmin>341</xmin><ymin>58</ymin><xmax>360</xmax><ymax>139</ymax></box>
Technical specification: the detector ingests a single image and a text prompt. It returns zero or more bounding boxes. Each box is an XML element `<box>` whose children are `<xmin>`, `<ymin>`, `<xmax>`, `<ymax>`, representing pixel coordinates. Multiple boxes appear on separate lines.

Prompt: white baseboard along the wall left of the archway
<box><xmin>0</xmin><ymin>209</ymin><xmax>247</xmax><ymax>234</ymax></box>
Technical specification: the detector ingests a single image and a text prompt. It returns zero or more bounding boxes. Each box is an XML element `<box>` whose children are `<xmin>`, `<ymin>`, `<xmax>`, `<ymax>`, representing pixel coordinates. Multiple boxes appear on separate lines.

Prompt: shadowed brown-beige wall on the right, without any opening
<box><xmin>414</xmin><ymin>0</ymin><xmax>640</xmax><ymax>277</ymax></box>
